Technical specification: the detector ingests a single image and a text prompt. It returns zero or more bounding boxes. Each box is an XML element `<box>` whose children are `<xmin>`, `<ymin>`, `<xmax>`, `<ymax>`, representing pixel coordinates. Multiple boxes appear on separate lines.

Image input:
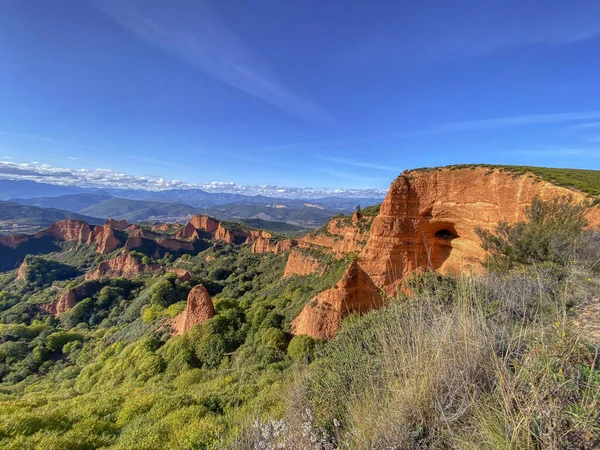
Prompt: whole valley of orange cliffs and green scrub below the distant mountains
<box><xmin>0</xmin><ymin>165</ymin><xmax>600</xmax><ymax>449</ymax></box>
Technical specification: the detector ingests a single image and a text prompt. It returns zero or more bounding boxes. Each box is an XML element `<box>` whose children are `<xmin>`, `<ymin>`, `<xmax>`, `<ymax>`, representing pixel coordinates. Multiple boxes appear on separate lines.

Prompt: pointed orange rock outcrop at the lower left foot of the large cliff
<box><xmin>291</xmin><ymin>261</ymin><xmax>383</xmax><ymax>339</ymax></box>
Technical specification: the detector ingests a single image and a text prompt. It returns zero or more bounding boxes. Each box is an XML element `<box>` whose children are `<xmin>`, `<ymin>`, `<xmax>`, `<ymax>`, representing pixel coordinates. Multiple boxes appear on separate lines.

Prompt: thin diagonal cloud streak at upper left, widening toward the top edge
<box><xmin>94</xmin><ymin>0</ymin><xmax>333</xmax><ymax>124</ymax></box>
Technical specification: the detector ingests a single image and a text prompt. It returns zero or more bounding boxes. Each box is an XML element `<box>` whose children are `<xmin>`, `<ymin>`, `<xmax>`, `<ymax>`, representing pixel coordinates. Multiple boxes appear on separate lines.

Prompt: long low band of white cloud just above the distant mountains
<box><xmin>0</xmin><ymin>161</ymin><xmax>386</xmax><ymax>198</ymax></box>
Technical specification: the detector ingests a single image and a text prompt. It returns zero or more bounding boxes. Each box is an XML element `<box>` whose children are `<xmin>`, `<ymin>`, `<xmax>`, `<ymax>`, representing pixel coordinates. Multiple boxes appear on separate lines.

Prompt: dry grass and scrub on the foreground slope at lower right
<box><xmin>237</xmin><ymin>262</ymin><xmax>600</xmax><ymax>450</ymax></box>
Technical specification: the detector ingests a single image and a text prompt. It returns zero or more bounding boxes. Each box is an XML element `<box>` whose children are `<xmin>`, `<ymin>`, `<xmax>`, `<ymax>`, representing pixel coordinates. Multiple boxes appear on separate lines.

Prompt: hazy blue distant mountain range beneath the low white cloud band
<box><xmin>0</xmin><ymin>180</ymin><xmax>381</xmax><ymax>229</ymax></box>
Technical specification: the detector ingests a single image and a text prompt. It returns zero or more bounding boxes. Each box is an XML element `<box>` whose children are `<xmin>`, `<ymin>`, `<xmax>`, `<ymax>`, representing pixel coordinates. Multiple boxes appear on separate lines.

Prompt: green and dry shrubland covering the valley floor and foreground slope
<box><xmin>0</xmin><ymin>199</ymin><xmax>600</xmax><ymax>449</ymax></box>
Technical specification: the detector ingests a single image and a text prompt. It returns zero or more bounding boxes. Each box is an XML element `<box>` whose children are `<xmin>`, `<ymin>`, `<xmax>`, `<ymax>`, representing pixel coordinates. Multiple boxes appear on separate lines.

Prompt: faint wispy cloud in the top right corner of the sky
<box><xmin>348</xmin><ymin>0</ymin><xmax>600</xmax><ymax>66</ymax></box>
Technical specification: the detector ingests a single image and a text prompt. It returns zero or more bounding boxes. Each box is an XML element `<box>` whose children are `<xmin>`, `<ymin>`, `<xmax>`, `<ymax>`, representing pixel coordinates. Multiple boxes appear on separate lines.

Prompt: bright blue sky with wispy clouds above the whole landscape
<box><xmin>0</xmin><ymin>0</ymin><xmax>600</xmax><ymax>193</ymax></box>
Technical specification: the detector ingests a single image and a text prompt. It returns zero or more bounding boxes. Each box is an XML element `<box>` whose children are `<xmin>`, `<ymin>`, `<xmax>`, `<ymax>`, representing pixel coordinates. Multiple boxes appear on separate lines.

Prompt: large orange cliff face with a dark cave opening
<box><xmin>359</xmin><ymin>167</ymin><xmax>598</xmax><ymax>293</ymax></box>
